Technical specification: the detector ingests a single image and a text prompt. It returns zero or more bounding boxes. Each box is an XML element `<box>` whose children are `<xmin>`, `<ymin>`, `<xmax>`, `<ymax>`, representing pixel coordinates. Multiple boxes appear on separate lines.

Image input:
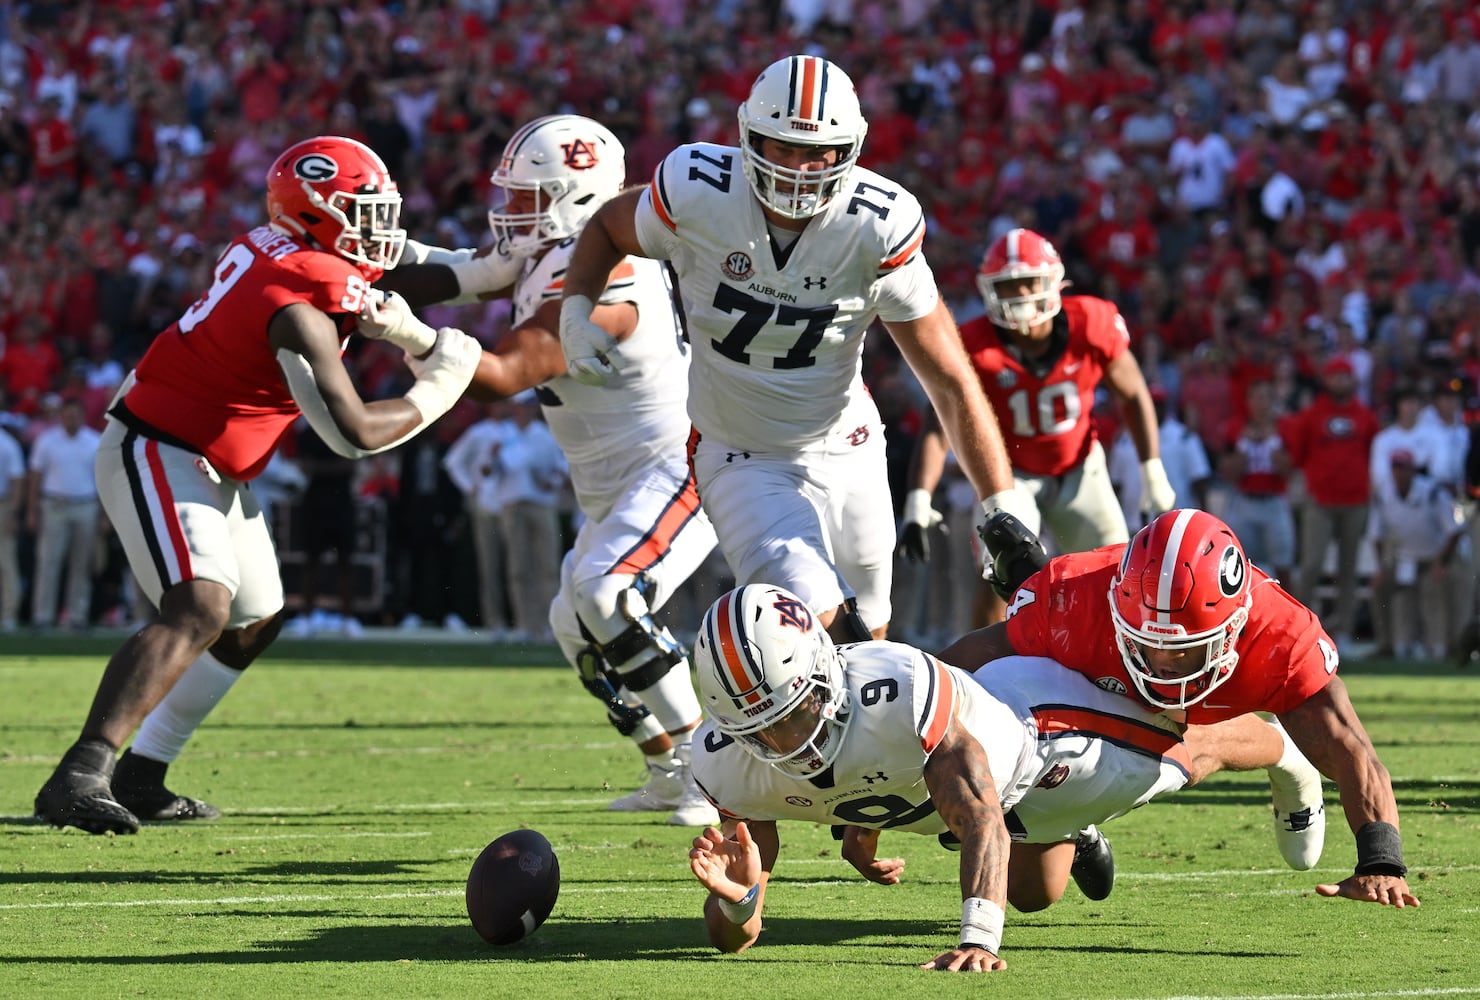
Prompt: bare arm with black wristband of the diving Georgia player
<box><xmin>1279</xmin><ymin>678</ymin><xmax>1419</xmax><ymax>908</ymax></box>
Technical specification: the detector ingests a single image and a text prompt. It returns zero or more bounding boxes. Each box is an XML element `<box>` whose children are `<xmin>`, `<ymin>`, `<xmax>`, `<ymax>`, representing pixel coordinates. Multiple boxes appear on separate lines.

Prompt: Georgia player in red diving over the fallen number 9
<box><xmin>941</xmin><ymin>509</ymin><xmax>1418</xmax><ymax>907</ymax></box>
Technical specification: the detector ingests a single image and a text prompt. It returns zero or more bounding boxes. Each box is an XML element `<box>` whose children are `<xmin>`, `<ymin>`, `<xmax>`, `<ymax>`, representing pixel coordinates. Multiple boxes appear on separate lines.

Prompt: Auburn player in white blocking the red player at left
<box><xmin>370</xmin><ymin>114</ymin><xmax>715</xmax><ymax>825</ymax></box>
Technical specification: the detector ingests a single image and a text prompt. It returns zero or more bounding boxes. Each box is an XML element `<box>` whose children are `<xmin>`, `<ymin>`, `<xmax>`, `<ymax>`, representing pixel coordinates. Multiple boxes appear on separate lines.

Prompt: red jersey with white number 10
<box><xmin>961</xmin><ymin>296</ymin><xmax>1131</xmax><ymax>476</ymax></box>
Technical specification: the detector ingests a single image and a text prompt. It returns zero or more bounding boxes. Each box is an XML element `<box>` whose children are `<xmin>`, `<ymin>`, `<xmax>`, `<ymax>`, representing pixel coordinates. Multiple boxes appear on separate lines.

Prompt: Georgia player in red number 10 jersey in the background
<box><xmin>900</xmin><ymin>229</ymin><xmax>1175</xmax><ymax>621</ymax></box>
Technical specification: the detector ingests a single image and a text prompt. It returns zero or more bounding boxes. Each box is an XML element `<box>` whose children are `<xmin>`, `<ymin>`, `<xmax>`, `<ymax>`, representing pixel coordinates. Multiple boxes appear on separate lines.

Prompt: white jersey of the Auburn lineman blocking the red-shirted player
<box><xmin>514</xmin><ymin>240</ymin><xmax>688</xmax><ymax>519</ymax></box>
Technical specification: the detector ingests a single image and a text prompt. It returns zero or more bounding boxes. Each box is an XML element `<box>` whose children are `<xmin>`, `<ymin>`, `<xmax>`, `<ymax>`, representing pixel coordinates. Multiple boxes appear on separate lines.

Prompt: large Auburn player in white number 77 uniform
<box><xmin>561</xmin><ymin>56</ymin><xmax>1036</xmax><ymax>639</ymax></box>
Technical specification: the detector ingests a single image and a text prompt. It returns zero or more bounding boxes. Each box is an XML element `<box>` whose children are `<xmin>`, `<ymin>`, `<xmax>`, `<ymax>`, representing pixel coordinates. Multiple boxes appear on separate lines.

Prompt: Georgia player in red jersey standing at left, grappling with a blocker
<box><xmin>36</xmin><ymin>136</ymin><xmax>482</xmax><ymax>833</ymax></box>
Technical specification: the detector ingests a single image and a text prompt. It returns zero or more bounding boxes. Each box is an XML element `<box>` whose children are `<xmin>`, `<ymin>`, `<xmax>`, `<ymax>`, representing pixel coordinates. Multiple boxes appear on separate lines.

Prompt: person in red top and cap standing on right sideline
<box><xmin>1280</xmin><ymin>358</ymin><xmax>1378</xmax><ymax>646</ymax></box>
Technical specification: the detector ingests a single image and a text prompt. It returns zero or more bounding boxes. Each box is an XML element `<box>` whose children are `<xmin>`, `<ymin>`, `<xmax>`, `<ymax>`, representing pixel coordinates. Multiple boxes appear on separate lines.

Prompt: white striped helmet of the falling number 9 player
<box><xmin>694</xmin><ymin>584</ymin><xmax>848</xmax><ymax>778</ymax></box>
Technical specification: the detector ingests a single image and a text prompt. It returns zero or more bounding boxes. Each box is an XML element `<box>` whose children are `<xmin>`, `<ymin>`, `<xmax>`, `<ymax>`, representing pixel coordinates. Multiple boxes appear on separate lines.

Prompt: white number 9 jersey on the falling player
<box><xmin>693</xmin><ymin>641</ymin><xmax>1039</xmax><ymax>834</ymax></box>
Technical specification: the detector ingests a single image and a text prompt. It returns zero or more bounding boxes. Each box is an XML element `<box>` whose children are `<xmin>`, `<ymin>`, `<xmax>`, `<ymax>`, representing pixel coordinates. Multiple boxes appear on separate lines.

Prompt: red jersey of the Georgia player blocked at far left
<box><xmin>124</xmin><ymin>226</ymin><xmax>379</xmax><ymax>481</ymax></box>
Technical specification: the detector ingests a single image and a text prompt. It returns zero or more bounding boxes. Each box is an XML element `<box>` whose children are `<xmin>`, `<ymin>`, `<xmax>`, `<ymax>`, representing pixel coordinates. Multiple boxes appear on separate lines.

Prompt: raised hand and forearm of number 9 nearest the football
<box><xmin>688</xmin><ymin>820</ymin><xmax>780</xmax><ymax>953</ymax></box>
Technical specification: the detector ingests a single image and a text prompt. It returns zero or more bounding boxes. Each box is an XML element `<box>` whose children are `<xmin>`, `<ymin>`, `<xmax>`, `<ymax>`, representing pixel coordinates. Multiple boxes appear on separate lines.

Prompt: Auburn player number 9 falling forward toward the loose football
<box><xmin>690</xmin><ymin>584</ymin><xmax>1313</xmax><ymax>972</ymax></box>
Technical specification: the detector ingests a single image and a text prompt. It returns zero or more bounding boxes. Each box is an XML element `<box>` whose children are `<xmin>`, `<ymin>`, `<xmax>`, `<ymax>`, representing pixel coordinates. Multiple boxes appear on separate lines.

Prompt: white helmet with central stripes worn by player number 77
<box><xmin>739</xmin><ymin>56</ymin><xmax>869</xmax><ymax>219</ymax></box>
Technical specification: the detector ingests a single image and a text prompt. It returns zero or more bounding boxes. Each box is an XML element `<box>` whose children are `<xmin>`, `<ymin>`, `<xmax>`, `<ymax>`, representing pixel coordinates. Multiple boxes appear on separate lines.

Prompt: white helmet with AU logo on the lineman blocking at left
<box><xmin>488</xmin><ymin>114</ymin><xmax>628</xmax><ymax>257</ymax></box>
